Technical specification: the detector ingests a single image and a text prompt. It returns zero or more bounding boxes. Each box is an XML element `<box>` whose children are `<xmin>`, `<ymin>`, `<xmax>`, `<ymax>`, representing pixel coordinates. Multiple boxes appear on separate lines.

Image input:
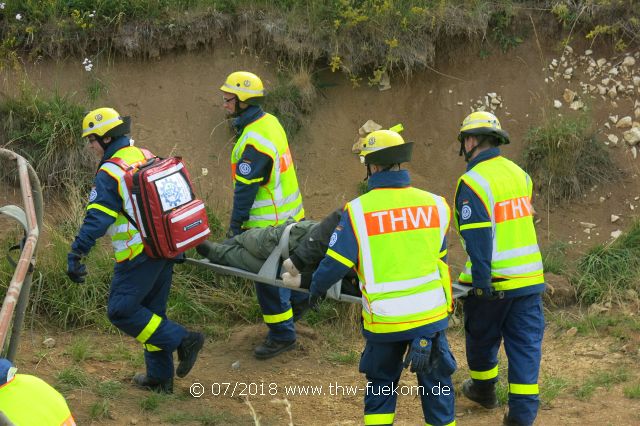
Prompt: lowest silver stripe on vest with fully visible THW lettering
<box><xmin>362</xmin><ymin>287</ymin><xmax>447</xmax><ymax>317</ymax></box>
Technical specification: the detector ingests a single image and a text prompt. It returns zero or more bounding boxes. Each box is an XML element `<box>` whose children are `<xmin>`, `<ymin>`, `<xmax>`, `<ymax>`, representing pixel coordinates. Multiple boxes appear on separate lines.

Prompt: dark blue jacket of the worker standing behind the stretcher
<box><xmin>229</xmin><ymin>105</ymin><xmax>273</xmax><ymax>235</ymax></box>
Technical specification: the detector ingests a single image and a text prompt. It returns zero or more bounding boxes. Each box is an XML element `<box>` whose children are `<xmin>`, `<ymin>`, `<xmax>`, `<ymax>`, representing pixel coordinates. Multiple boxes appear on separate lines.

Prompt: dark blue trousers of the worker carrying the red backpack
<box><xmin>107</xmin><ymin>253</ymin><xmax>187</xmax><ymax>379</ymax></box>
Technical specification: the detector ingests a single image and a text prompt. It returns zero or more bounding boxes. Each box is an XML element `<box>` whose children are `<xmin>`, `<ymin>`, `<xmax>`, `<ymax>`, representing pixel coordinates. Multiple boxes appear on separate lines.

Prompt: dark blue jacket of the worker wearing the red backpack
<box><xmin>71</xmin><ymin>136</ymin><xmax>131</xmax><ymax>255</ymax></box>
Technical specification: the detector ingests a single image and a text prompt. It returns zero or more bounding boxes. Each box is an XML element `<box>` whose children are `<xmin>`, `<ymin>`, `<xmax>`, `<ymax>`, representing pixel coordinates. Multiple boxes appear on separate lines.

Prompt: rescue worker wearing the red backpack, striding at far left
<box><xmin>67</xmin><ymin>108</ymin><xmax>204</xmax><ymax>393</ymax></box>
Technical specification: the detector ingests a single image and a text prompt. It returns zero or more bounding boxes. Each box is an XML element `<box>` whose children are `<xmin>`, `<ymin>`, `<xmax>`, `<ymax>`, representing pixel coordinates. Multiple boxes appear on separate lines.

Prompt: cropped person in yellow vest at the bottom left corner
<box><xmin>0</xmin><ymin>358</ymin><xmax>76</xmax><ymax>426</ymax></box>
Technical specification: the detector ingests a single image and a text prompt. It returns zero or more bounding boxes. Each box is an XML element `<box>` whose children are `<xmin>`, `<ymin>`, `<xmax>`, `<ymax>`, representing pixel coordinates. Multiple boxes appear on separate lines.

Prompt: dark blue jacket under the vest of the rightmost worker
<box><xmin>455</xmin><ymin>147</ymin><xmax>544</xmax><ymax>297</ymax></box>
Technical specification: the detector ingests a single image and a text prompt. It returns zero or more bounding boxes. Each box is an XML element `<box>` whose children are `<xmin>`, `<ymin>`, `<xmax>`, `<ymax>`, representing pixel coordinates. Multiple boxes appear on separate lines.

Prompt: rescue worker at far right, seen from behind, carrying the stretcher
<box><xmin>455</xmin><ymin>111</ymin><xmax>545</xmax><ymax>425</ymax></box>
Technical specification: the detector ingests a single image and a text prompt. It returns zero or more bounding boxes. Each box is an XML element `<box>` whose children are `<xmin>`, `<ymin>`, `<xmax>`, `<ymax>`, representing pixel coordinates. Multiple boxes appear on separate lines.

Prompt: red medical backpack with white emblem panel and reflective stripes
<box><xmin>107</xmin><ymin>149</ymin><xmax>211</xmax><ymax>259</ymax></box>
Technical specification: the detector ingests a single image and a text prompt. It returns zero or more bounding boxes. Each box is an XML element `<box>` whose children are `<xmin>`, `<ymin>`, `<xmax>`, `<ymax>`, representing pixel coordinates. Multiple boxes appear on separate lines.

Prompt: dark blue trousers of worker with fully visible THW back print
<box><xmin>360</xmin><ymin>338</ymin><xmax>455</xmax><ymax>426</ymax></box>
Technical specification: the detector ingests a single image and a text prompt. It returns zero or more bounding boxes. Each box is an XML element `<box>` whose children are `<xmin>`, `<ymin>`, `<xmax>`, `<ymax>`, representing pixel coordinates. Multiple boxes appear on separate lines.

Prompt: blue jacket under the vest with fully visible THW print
<box><xmin>309</xmin><ymin>170</ymin><xmax>449</xmax><ymax>342</ymax></box>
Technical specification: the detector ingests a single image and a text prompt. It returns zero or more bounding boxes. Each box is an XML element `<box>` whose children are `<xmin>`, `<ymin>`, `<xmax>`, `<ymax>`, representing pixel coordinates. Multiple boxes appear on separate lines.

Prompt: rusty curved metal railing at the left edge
<box><xmin>0</xmin><ymin>148</ymin><xmax>43</xmax><ymax>362</ymax></box>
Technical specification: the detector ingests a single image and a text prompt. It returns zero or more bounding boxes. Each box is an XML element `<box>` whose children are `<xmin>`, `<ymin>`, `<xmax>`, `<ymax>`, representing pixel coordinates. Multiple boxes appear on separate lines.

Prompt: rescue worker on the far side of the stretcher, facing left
<box><xmin>220</xmin><ymin>71</ymin><xmax>306</xmax><ymax>359</ymax></box>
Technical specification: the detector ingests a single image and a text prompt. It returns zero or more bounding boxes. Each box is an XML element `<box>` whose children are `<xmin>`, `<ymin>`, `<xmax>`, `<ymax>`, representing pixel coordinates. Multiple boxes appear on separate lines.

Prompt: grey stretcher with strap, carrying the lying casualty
<box><xmin>186</xmin><ymin>223</ymin><xmax>472</xmax><ymax>303</ymax></box>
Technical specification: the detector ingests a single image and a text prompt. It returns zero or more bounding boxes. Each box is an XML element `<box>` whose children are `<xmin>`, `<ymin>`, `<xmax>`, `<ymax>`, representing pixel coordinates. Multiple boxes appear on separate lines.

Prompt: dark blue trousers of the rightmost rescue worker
<box><xmin>464</xmin><ymin>294</ymin><xmax>544</xmax><ymax>425</ymax></box>
